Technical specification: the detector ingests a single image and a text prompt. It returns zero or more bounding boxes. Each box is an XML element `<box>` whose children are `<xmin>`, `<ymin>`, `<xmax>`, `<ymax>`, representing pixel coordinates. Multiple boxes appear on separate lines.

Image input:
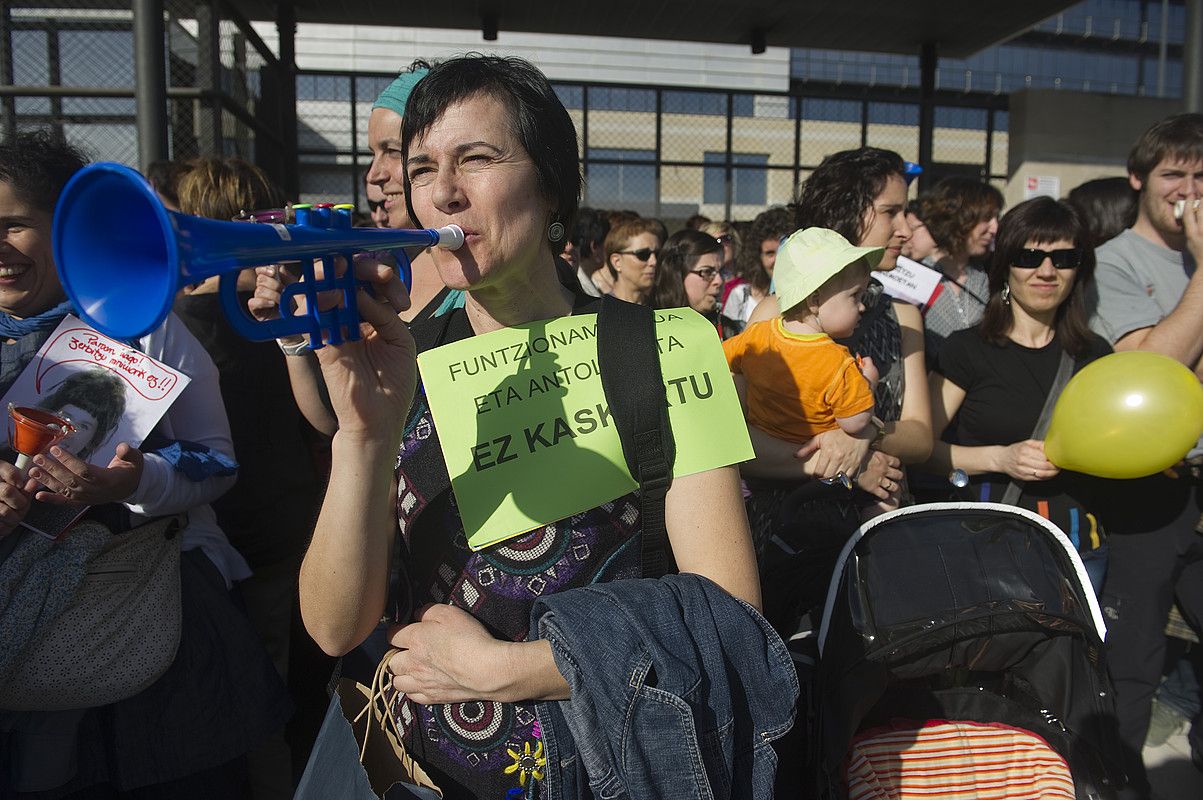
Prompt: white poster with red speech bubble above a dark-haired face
<box><xmin>0</xmin><ymin>315</ymin><xmax>189</xmax><ymax>537</ymax></box>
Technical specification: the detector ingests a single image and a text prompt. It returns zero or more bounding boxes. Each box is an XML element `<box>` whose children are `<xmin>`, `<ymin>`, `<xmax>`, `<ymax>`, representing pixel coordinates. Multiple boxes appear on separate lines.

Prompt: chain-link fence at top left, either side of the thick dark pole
<box><xmin>0</xmin><ymin>0</ymin><xmax>284</xmax><ymax>179</ymax></box>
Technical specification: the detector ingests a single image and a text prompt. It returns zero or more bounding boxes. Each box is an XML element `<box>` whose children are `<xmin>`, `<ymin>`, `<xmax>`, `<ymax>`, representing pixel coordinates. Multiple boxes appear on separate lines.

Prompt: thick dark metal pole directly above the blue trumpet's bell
<box><xmin>134</xmin><ymin>0</ymin><xmax>167</xmax><ymax>171</ymax></box>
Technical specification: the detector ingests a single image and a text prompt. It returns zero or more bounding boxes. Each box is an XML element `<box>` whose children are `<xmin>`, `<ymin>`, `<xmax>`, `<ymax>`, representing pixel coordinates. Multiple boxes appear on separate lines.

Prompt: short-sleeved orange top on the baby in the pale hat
<box><xmin>723</xmin><ymin>318</ymin><xmax>873</xmax><ymax>443</ymax></box>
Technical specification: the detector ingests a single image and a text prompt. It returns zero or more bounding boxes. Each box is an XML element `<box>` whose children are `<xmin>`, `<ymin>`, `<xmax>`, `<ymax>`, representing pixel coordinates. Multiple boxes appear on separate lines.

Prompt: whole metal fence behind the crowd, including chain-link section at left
<box><xmin>0</xmin><ymin>0</ymin><xmax>1007</xmax><ymax>223</ymax></box>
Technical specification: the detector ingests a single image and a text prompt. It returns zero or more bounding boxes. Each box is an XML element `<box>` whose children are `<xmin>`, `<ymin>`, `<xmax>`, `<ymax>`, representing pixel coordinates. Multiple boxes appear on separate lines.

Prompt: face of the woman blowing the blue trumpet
<box><xmin>405</xmin><ymin>95</ymin><xmax>558</xmax><ymax>290</ymax></box>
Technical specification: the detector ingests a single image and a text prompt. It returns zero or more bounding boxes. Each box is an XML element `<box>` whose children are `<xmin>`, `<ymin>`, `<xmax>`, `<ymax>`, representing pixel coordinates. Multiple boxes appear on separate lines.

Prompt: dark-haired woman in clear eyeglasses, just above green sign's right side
<box><xmin>652</xmin><ymin>229</ymin><xmax>743</xmax><ymax>339</ymax></box>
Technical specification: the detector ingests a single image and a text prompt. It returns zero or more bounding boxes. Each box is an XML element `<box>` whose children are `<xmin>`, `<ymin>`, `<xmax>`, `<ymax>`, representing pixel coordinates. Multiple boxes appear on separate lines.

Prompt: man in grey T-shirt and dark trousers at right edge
<box><xmin>1091</xmin><ymin>114</ymin><xmax>1203</xmax><ymax>798</ymax></box>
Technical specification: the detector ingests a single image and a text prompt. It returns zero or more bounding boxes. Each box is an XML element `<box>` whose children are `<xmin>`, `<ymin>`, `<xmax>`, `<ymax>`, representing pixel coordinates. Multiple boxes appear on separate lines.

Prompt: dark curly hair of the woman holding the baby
<box><xmin>793</xmin><ymin>147</ymin><xmax>906</xmax><ymax>244</ymax></box>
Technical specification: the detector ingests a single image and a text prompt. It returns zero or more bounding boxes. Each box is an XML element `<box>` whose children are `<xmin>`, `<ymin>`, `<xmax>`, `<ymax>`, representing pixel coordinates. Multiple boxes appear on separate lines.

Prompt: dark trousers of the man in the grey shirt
<box><xmin>1102</xmin><ymin>476</ymin><xmax>1203</xmax><ymax>798</ymax></box>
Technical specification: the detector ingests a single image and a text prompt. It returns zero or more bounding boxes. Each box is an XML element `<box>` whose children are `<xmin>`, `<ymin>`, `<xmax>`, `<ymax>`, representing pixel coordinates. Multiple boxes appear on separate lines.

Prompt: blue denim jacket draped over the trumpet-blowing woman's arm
<box><xmin>531</xmin><ymin>575</ymin><xmax>798</xmax><ymax>800</ymax></box>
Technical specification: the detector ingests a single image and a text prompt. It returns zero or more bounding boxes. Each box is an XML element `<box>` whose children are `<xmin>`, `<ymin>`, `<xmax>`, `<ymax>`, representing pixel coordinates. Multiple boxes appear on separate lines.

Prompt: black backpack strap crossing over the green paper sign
<box><xmin>598</xmin><ymin>296</ymin><xmax>676</xmax><ymax>577</ymax></box>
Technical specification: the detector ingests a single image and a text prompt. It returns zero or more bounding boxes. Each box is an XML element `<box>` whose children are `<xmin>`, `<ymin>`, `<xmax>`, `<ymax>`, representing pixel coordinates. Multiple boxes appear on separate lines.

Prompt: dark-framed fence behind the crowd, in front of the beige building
<box><xmin>297</xmin><ymin>72</ymin><xmax>1007</xmax><ymax>224</ymax></box>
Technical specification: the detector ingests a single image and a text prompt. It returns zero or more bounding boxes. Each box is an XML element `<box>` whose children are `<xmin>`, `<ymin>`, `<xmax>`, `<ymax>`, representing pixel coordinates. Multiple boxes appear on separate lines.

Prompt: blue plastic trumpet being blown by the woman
<box><xmin>52</xmin><ymin>162</ymin><xmax>463</xmax><ymax>348</ymax></box>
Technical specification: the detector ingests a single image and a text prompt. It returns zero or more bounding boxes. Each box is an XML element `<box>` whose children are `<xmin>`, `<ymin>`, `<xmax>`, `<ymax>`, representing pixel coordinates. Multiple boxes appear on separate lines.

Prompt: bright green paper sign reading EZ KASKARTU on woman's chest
<box><xmin>417</xmin><ymin>308</ymin><xmax>753</xmax><ymax>550</ymax></box>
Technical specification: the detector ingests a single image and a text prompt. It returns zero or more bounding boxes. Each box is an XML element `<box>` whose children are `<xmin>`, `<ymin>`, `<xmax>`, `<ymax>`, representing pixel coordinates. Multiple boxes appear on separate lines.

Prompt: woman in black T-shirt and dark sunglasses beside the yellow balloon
<box><xmin>924</xmin><ymin>197</ymin><xmax>1112</xmax><ymax>587</ymax></box>
